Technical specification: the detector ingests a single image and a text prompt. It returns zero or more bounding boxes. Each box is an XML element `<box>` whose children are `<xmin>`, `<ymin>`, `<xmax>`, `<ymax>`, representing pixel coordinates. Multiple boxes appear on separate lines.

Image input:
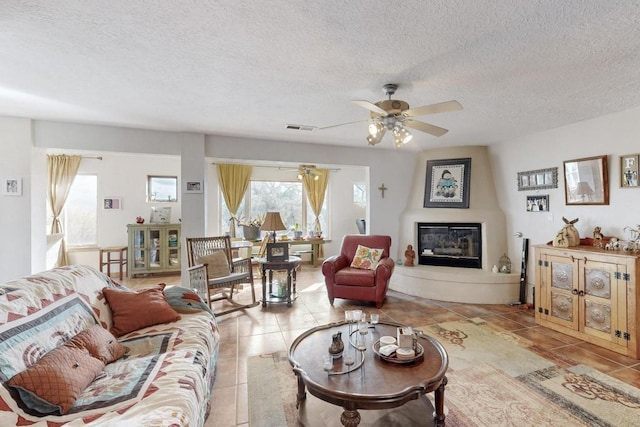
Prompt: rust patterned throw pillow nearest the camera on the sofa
<box><xmin>6</xmin><ymin>345</ymin><xmax>104</xmax><ymax>415</ymax></box>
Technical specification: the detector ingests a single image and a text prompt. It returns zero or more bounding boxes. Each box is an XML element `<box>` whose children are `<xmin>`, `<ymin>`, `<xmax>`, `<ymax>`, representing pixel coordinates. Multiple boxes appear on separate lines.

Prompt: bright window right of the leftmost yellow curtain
<box><xmin>59</xmin><ymin>175</ymin><xmax>98</xmax><ymax>246</ymax></box>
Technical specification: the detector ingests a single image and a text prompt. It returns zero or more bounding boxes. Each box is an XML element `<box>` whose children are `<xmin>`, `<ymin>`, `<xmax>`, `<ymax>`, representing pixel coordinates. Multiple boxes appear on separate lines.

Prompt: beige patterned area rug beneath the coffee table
<box><xmin>248</xmin><ymin>319</ymin><xmax>640</xmax><ymax>427</ymax></box>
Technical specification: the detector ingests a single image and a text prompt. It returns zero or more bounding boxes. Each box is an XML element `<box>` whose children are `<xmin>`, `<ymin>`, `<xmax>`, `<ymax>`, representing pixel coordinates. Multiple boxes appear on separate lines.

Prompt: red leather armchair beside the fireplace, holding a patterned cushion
<box><xmin>322</xmin><ymin>234</ymin><xmax>395</xmax><ymax>308</ymax></box>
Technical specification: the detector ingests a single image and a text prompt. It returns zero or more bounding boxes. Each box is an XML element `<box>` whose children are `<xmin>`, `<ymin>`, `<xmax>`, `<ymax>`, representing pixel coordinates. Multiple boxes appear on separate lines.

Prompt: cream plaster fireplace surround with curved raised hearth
<box><xmin>389</xmin><ymin>146</ymin><xmax>520</xmax><ymax>304</ymax></box>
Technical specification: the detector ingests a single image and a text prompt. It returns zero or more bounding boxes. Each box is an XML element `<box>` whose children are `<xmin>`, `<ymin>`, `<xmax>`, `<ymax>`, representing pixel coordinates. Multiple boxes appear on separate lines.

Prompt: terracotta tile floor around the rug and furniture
<box><xmin>122</xmin><ymin>265</ymin><xmax>640</xmax><ymax>427</ymax></box>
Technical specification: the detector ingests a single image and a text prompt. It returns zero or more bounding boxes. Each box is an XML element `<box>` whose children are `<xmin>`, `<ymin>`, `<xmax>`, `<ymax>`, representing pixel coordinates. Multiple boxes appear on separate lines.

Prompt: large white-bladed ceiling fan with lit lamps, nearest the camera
<box><xmin>318</xmin><ymin>83</ymin><xmax>462</xmax><ymax>147</ymax></box>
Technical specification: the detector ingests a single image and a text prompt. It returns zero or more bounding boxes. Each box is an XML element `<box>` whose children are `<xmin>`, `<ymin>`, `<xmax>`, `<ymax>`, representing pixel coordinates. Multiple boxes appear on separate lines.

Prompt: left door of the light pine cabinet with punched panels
<box><xmin>544</xmin><ymin>255</ymin><xmax>579</xmax><ymax>330</ymax></box>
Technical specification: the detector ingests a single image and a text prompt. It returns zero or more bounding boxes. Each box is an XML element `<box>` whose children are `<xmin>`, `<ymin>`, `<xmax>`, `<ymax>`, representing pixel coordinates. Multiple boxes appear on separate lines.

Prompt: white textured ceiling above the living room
<box><xmin>0</xmin><ymin>0</ymin><xmax>640</xmax><ymax>150</ymax></box>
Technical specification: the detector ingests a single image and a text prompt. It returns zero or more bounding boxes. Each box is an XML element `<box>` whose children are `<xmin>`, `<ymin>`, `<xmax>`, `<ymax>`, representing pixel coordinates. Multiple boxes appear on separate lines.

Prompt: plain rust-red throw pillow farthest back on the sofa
<box><xmin>102</xmin><ymin>283</ymin><xmax>180</xmax><ymax>337</ymax></box>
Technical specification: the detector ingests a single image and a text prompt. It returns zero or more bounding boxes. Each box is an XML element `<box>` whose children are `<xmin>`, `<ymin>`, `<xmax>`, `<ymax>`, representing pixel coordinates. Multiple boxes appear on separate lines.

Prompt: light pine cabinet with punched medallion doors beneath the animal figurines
<box><xmin>535</xmin><ymin>245</ymin><xmax>640</xmax><ymax>359</ymax></box>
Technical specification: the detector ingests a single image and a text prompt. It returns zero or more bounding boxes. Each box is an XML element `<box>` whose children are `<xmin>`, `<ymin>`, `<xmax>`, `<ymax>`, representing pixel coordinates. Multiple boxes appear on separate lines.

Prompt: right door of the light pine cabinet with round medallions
<box><xmin>580</xmin><ymin>260</ymin><xmax>627</xmax><ymax>346</ymax></box>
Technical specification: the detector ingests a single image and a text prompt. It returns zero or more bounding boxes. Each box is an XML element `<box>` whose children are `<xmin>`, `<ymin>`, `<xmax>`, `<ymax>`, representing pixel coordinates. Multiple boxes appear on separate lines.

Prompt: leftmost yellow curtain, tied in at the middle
<box><xmin>47</xmin><ymin>154</ymin><xmax>82</xmax><ymax>267</ymax></box>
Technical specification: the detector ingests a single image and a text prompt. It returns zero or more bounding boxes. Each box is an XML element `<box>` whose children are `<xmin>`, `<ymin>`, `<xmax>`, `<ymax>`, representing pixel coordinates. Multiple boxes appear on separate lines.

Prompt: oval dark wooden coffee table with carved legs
<box><xmin>289</xmin><ymin>322</ymin><xmax>449</xmax><ymax>427</ymax></box>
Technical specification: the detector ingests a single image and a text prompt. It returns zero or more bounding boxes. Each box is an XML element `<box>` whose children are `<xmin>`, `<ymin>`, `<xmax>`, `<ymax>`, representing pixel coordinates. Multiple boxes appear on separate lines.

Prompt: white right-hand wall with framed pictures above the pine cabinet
<box><xmin>489</xmin><ymin>104</ymin><xmax>640</xmax><ymax>298</ymax></box>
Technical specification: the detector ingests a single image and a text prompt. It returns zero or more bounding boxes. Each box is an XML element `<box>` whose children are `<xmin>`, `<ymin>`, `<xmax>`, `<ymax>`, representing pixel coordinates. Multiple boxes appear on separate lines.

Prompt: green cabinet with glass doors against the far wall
<box><xmin>127</xmin><ymin>224</ymin><xmax>182</xmax><ymax>277</ymax></box>
